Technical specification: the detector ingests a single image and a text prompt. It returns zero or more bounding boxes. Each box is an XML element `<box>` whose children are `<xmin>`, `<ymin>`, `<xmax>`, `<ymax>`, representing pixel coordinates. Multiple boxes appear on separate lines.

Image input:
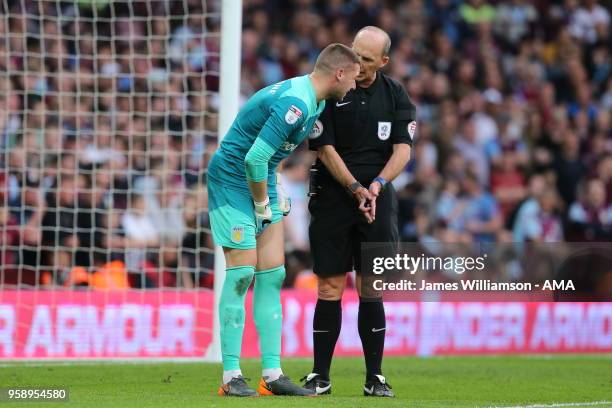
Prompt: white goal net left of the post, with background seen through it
<box><xmin>0</xmin><ymin>0</ymin><xmax>226</xmax><ymax>359</ymax></box>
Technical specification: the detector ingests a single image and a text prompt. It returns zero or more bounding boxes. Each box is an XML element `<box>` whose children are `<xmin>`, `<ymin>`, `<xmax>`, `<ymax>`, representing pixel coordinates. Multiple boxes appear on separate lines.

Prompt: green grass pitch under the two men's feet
<box><xmin>0</xmin><ymin>355</ymin><xmax>612</xmax><ymax>408</ymax></box>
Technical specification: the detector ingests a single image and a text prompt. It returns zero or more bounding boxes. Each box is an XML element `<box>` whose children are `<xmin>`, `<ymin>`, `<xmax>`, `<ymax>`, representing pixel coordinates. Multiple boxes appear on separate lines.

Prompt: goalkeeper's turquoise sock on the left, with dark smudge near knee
<box><xmin>219</xmin><ymin>266</ymin><xmax>255</xmax><ymax>371</ymax></box>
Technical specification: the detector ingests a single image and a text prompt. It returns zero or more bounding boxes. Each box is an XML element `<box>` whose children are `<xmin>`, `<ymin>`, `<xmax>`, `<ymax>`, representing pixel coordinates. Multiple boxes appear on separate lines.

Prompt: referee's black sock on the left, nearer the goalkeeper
<box><xmin>312</xmin><ymin>299</ymin><xmax>342</xmax><ymax>380</ymax></box>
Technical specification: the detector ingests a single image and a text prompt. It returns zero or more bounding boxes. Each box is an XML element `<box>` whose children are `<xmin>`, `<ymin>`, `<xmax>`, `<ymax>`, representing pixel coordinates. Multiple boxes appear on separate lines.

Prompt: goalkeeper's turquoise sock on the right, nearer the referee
<box><xmin>253</xmin><ymin>266</ymin><xmax>285</xmax><ymax>370</ymax></box>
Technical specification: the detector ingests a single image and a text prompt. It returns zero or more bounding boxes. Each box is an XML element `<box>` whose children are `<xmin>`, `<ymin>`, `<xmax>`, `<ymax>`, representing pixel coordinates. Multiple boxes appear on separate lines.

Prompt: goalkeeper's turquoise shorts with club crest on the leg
<box><xmin>208</xmin><ymin>179</ymin><xmax>283</xmax><ymax>249</ymax></box>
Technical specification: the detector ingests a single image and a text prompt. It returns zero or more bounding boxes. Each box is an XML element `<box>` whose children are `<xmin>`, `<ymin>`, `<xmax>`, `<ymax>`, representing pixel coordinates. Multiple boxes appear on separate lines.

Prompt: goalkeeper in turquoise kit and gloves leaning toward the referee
<box><xmin>208</xmin><ymin>44</ymin><xmax>359</xmax><ymax>396</ymax></box>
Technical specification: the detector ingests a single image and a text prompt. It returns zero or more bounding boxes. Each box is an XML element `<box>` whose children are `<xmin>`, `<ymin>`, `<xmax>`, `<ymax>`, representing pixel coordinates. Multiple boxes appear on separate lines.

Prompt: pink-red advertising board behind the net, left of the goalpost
<box><xmin>0</xmin><ymin>291</ymin><xmax>213</xmax><ymax>358</ymax></box>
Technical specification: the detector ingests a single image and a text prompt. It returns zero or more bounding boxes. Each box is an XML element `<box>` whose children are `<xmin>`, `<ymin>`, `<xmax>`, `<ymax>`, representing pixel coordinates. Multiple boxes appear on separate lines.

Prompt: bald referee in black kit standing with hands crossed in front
<box><xmin>303</xmin><ymin>26</ymin><xmax>416</xmax><ymax>397</ymax></box>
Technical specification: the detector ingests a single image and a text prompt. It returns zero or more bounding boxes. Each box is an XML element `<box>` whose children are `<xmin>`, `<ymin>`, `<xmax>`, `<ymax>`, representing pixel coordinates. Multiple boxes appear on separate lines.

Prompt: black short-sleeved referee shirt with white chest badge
<box><xmin>309</xmin><ymin>72</ymin><xmax>416</xmax><ymax>186</ymax></box>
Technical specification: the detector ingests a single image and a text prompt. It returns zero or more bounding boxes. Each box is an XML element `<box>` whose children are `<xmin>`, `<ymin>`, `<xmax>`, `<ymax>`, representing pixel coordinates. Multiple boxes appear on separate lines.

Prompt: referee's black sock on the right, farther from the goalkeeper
<box><xmin>357</xmin><ymin>298</ymin><xmax>386</xmax><ymax>380</ymax></box>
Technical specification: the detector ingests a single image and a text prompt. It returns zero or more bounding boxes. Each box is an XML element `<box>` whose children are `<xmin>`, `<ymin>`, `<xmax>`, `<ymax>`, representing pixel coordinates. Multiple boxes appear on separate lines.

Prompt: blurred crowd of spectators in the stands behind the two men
<box><xmin>0</xmin><ymin>0</ymin><xmax>612</xmax><ymax>287</ymax></box>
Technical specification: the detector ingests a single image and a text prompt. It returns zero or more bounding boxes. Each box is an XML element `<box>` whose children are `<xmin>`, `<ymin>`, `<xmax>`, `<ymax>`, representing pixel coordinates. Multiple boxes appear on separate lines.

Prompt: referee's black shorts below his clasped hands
<box><xmin>308</xmin><ymin>183</ymin><xmax>399</xmax><ymax>277</ymax></box>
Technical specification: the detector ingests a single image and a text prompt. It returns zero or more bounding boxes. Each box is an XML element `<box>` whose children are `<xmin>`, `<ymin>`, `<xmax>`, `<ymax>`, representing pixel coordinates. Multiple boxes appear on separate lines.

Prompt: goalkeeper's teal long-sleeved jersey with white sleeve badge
<box><xmin>208</xmin><ymin>75</ymin><xmax>325</xmax><ymax>197</ymax></box>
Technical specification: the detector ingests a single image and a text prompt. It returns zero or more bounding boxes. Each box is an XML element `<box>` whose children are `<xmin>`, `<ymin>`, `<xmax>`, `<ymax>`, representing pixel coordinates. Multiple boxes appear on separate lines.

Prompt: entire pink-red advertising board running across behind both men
<box><xmin>0</xmin><ymin>290</ymin><xmax>612</xmax><ymax>359</ymax></box>
